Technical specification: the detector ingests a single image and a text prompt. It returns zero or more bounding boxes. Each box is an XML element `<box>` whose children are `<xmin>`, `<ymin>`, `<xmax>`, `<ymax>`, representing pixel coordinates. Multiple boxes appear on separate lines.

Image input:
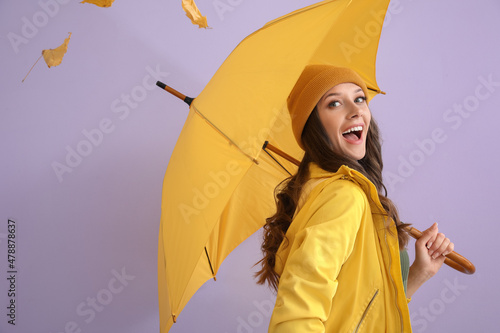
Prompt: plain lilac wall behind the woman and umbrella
<box><xmin>0</xmin><ymin>0</ymin><xmax>500</xmax><ymax>333</ymax></box>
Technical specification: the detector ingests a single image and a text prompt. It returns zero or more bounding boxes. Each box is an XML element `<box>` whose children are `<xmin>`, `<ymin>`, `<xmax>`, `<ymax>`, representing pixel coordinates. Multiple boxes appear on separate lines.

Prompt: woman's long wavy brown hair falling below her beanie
<box><xmin>255</xmin><ymin>108</ymin><xmax>408</xmax><ymax>290</ymax></box>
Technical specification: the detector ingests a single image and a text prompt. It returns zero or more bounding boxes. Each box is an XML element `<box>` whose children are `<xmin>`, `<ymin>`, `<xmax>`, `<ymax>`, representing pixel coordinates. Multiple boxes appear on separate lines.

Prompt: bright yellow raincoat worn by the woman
<box><xmin>269</xmin><ymin>164</ymin><xmax>411</xmax><ymax>333</ymax></box>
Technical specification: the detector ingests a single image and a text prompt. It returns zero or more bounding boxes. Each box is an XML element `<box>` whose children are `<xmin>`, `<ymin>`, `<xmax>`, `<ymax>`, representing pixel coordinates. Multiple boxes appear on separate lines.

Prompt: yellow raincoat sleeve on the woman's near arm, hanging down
<box><xmin>269</xmin><ymin>181</ymin><xmax>366</xmax><ymax>333</ymax></box>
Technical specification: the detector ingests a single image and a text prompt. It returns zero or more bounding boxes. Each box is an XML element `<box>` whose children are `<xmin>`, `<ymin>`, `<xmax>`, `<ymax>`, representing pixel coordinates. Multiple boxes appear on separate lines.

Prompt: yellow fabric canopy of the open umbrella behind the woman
<box><xmin>158</xmin><ymin>0</ymin><xmax>389</xmax><ymax>332</ymax></box>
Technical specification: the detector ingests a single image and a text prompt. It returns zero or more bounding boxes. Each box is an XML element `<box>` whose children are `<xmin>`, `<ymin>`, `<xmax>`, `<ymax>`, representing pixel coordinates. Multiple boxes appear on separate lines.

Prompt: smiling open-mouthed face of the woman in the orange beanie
<box><xmin>317</xmin><ymin>83</ymin><xmax>371</xmax><ymax>160</ymax></box>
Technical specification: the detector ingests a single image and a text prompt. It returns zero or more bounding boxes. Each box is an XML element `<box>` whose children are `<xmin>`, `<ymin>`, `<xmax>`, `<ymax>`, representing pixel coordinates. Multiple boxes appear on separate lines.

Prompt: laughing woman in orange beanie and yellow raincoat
<box><xmin>257</xmin><ymin>65</ymin><xmax>453</xmax><ymax>333</ymax></box>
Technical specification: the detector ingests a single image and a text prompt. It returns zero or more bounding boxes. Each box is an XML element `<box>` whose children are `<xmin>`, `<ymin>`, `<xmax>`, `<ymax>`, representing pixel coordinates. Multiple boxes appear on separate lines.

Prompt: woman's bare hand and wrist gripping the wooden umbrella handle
<box><xmin>406</xmin><ymin>223</ymin><xmax>454</xmax><ymax>298</ymax></box>
